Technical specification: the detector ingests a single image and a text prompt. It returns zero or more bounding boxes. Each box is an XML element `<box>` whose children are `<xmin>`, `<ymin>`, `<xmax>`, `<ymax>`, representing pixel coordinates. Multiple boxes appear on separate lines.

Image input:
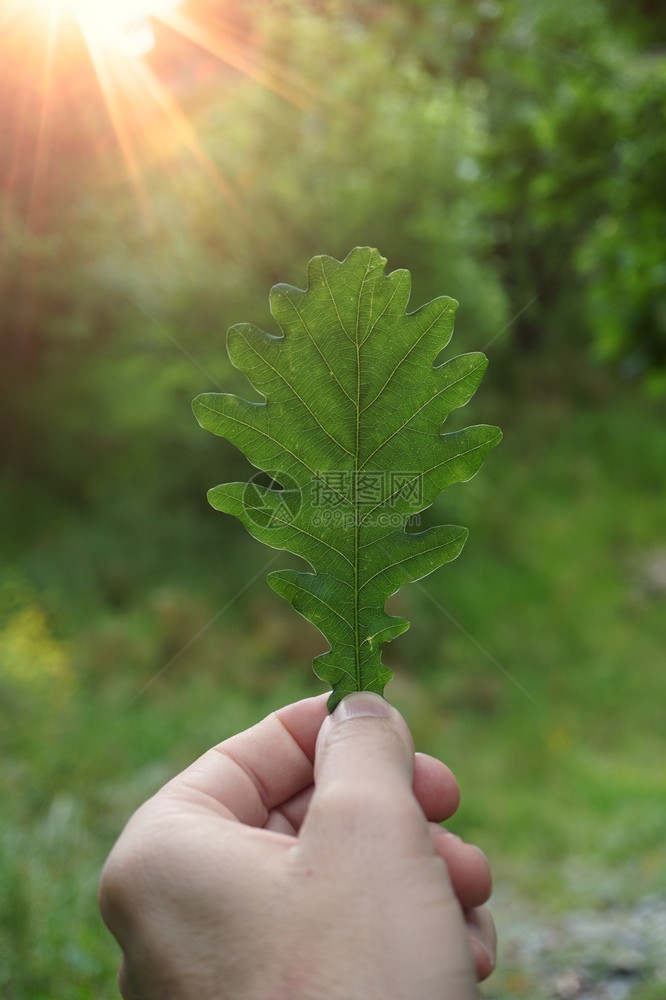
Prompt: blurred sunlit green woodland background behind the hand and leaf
<box><xmin>0</xmin><ymin>0</ymin><xmax>666</xmax><ymax>1000</ymax></box>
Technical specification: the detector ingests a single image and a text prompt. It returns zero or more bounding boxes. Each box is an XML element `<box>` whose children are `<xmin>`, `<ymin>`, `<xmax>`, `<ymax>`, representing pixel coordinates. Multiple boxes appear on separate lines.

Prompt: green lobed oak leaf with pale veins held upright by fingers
<box><xmin>193</xmin><ymin>247</ymin><xmax>502</xmax><ymax>710</ymax></box>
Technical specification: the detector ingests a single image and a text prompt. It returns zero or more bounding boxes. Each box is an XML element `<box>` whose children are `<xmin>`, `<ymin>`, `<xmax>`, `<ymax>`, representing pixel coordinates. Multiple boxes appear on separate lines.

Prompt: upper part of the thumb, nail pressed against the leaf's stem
<box><xmin>302</xmin><ymin>691</ymin><xmax>424</xmax><ymax>839</ymax></box>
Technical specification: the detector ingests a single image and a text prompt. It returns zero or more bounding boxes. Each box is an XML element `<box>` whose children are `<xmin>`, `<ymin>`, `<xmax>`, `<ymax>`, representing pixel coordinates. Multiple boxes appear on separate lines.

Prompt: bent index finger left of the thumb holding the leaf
<box><xmin>163</xmin><ymin>695</ymin><xmax>327</xmax><ymax>826</ymax></box>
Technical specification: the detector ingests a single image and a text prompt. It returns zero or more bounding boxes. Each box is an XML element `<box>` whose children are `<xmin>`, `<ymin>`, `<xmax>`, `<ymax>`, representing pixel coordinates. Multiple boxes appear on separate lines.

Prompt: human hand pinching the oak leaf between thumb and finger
<box><xmin>100</xmin><ymin>693</ymin><xmax>495</xmax><ymax>1000</ymax></box>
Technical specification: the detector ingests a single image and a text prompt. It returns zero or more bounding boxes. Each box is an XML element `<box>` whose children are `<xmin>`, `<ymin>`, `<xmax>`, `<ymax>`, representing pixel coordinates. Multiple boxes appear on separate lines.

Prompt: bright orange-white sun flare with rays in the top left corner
<box><xmin>0</xmin><ymin>0</ymin><xmax>329</xmax><ymax>232</ymax></box>
